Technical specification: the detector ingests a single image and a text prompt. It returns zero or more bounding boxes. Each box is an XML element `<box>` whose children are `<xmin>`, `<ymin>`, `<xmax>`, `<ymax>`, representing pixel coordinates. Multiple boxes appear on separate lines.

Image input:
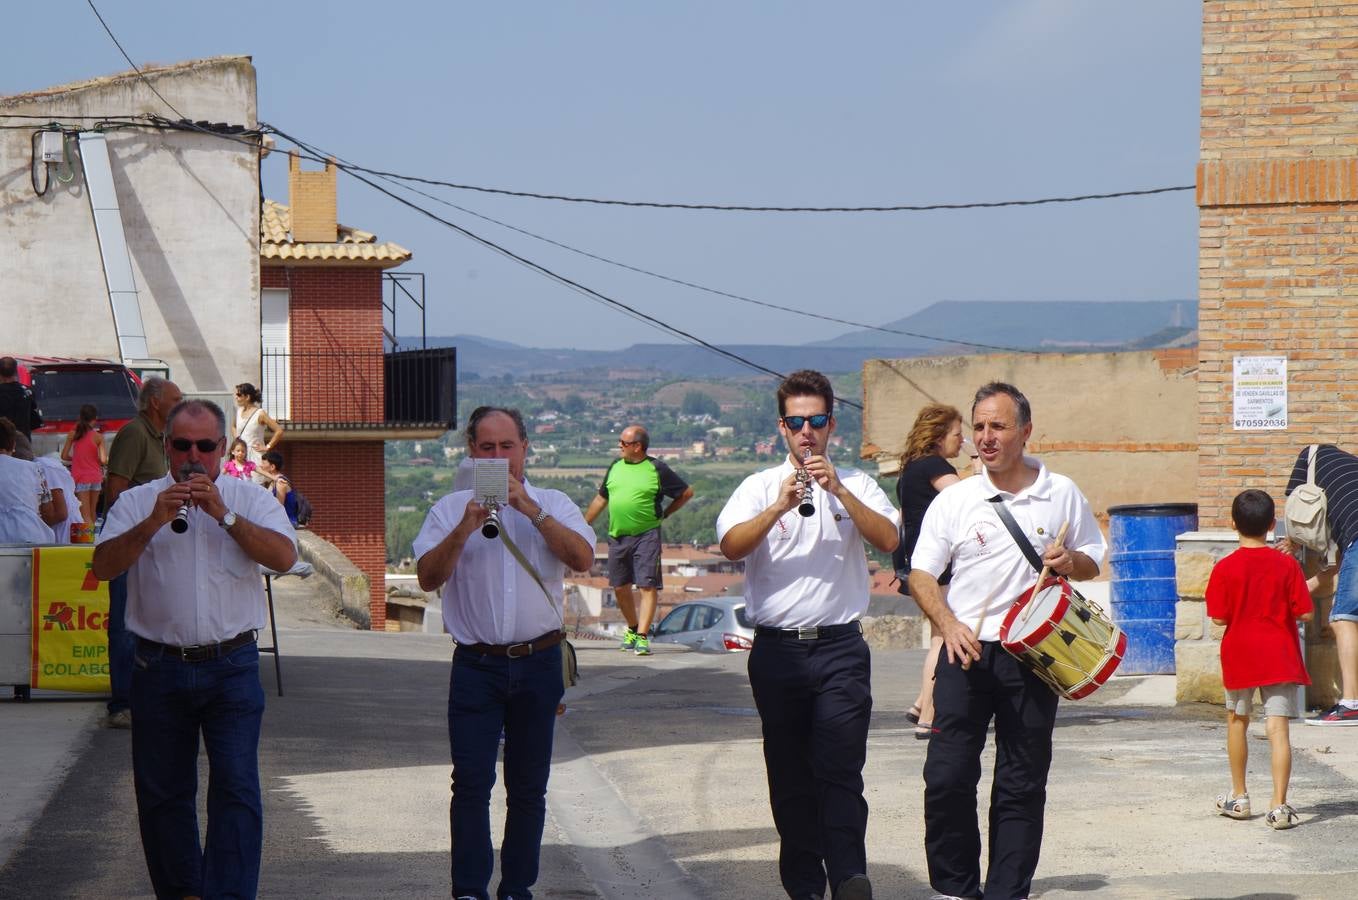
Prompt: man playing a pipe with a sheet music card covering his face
<box><xmin>414</xmin><ymin>406</ymin><xmax>595</xmax><ymax>900</ymax></box>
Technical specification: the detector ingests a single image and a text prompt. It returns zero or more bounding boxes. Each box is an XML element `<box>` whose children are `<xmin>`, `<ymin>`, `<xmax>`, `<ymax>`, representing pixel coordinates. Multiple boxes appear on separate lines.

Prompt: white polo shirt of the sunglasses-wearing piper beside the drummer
<box><xmin>717</xmin><ymin>459</ymin><xmax>900</xmax><ymax>629</ymax></box>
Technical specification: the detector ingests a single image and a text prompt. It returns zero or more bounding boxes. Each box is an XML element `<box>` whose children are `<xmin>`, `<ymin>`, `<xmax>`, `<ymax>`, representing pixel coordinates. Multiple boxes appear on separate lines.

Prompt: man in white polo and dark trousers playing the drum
<box><xmin>910</xmin><ymin>381</ymin><xmax>1107</xmax><ymax>900</ymax></box>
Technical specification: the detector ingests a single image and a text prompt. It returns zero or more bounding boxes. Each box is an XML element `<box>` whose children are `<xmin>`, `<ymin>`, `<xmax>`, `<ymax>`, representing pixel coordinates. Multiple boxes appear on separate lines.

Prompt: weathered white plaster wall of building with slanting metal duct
<box><xmin>0</xmin><ymin>57</ymin><xmax>259</xmax><ymax>394</ymax></box>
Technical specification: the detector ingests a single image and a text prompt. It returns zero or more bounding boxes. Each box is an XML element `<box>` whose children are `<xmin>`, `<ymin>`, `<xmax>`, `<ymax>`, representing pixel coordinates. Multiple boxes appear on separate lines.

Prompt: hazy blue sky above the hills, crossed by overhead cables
<box><xmin>0</xmin><ymin>0</ymin><xmax>1200</xmax><ymax>349</ymax></box>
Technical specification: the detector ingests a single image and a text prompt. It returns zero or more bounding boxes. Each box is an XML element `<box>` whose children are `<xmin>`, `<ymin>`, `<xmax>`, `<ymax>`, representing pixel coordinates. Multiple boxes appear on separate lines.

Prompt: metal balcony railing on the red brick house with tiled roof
<box><xmin>261</xmin><ymin>348</ymin><xmax>458</xmax><ymax>430</ymax></box>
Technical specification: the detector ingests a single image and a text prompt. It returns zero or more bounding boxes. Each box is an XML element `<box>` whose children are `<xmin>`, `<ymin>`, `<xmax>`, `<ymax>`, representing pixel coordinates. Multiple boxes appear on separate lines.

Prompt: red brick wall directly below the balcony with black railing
<box><xmin>289</xmin><ymin>437</ymin><xmax>387</xmax><ymax>631</ymax></box>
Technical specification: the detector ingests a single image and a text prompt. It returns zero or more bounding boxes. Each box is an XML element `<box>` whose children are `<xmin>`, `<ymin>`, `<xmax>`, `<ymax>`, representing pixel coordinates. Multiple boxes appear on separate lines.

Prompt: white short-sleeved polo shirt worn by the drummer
<box><xmin>910</xmin><ymin>456</ymin><xmax>1108</xmax><ymax>641</ymax></box>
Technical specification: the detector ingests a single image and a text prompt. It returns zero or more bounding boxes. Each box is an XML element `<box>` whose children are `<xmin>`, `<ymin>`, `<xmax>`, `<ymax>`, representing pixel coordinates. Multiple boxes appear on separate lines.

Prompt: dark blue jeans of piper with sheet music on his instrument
<box><xmin>448</xmin><ymin>646</ymin><xmax>565</xmax><ymax>900</ymax></box>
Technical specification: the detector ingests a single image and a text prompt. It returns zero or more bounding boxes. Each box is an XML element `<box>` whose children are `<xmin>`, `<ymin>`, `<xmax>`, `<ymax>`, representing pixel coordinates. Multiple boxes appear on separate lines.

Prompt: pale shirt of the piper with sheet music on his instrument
<box><xmin>414</xmin><ymin>483</ymin><xmax>595</xmax><ymax>645</ymax></box>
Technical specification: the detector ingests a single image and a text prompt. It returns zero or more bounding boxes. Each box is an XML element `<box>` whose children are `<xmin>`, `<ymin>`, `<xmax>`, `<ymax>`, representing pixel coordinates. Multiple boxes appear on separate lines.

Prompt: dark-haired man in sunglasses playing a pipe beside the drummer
<box><xmin>717</xmin><ymin>369</ymin><xmax>899</xmax><ymax>900</ymax></box>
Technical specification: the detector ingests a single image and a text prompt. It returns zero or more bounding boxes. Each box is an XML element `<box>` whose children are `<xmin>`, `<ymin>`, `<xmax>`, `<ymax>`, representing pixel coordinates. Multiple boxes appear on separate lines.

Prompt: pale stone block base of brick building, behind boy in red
<box><xmin>1175</xmin><ymin>531</ymin><xmax>1339</xmax><ymax>709</ymax></box>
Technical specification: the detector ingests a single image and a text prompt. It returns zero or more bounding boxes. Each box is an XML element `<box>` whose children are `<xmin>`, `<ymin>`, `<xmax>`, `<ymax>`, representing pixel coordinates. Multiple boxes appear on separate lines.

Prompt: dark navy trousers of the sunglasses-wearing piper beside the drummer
<box><xmin>750</xmin><ymin>630</ymin><xmax>872</xmax><ymax>900</ymax></box>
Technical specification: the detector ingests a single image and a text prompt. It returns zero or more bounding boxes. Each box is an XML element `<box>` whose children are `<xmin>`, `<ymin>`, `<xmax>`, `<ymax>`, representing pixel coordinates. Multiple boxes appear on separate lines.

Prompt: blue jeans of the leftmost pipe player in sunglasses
<box><xmin>132</xmin><ymin>643</ymin><xmax>263</xmax><ymax>897</ymax></box>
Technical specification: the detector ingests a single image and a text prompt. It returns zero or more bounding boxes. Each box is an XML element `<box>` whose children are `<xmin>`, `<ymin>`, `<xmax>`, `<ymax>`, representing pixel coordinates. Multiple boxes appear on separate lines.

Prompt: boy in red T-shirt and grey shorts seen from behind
<box><xmin>1207</xmin><ymin>490</ymin><xmax>1312</xmax><ymax>829</ymax></box>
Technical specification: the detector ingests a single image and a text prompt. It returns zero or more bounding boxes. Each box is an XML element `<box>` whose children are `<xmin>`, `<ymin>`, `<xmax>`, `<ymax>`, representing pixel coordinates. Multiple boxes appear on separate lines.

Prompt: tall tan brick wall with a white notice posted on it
<box><xmin>1198</xmin><ymin>0</ymin><xmax>1358</xmax><ymax>528</ymax></box>
